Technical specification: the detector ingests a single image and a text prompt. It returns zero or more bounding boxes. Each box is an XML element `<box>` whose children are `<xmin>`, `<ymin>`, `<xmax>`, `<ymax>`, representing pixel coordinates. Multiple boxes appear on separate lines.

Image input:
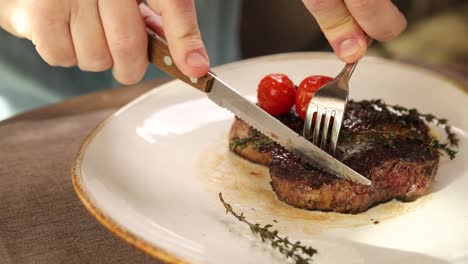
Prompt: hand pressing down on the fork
<box><xmin>303</xmin><ymin>0</ymin><xmax>406</xmax><ymax>62</ymax></box>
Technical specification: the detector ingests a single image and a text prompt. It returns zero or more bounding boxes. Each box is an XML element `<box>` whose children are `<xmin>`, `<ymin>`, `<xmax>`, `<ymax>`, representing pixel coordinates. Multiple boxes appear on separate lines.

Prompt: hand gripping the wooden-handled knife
<box><xmin>0</xmin><ymin>0</ymin><xmax>209</xmax><ymax>84</ymax></box>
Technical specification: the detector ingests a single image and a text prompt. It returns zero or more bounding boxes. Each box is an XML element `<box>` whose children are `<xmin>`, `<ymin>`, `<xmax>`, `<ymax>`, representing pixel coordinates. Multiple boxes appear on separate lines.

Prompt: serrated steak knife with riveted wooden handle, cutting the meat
<box><xmin>148</xmin><ymin>30</ymin><xmax>371</xmax><ymax>185</ymax></box>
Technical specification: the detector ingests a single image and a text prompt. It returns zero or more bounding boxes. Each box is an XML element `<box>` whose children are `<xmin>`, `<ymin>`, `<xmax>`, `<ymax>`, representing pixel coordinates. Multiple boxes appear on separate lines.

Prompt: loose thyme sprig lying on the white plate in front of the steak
<box><xmin>219</xmin><ymin>193</ymin><xmax>317</xmax><ymax>264</ymax></box>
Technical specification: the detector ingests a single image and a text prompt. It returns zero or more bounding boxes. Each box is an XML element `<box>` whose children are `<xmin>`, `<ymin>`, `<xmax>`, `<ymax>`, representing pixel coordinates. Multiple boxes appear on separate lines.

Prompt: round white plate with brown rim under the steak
<box><xmin>73</xmin><ymin>53</ymin><xmax>468</xmax><ymax>263</ymax></box>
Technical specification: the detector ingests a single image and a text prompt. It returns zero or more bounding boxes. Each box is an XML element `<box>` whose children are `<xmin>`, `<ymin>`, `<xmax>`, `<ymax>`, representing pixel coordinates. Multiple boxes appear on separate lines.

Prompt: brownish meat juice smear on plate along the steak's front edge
<box><xmin>197</xmin><ymin>135</ymin><xmax>428</xmax><ymax>234</ymax></box>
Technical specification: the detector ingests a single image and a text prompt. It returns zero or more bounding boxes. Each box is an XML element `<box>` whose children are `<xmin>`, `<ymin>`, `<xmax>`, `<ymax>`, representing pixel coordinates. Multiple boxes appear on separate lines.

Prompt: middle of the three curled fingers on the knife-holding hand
<box><xmin>70</xmin><ymin>0</ymin><xmax>112</xmax><ymax>72</ymax></box>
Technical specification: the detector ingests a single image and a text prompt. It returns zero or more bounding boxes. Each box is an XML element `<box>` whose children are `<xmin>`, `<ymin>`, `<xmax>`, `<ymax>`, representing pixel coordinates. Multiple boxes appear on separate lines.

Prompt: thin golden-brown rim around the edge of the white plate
<box><xmin>71</xmin><ymin>52</ymin><xmax>468</xmax><ymax>264</ymax></box>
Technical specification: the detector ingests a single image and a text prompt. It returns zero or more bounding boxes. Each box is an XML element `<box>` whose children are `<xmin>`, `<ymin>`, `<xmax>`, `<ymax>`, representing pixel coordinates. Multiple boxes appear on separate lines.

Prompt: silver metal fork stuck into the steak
<box><xmin>303</xmin><ymin>62</ymin><xmax>357</xmax><ymax>155</ymax></box>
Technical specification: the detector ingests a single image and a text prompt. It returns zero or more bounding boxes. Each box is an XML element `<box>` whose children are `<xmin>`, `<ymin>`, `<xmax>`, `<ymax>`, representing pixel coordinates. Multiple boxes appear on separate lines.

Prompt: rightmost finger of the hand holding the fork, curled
<box><xmin>345</xmin><ymin>0</ymin><xmax>407</xmax><ymax>41</ymax></box>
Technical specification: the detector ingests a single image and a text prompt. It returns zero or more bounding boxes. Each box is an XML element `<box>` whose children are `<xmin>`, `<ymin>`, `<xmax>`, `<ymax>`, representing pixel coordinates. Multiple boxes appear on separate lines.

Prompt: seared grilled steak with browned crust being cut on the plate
<box><xmin>230</xmin><ymin>101</ymin><xmax>439</xmax><ymax>214</ymax></box>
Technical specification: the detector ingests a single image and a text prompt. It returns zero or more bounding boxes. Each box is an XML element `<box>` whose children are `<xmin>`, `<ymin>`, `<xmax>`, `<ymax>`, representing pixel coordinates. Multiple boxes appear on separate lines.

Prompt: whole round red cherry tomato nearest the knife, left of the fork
<box><xmin>257</xmin><ymin>73</ymin><xmax>296</xmax><ymax>116</ymax></box>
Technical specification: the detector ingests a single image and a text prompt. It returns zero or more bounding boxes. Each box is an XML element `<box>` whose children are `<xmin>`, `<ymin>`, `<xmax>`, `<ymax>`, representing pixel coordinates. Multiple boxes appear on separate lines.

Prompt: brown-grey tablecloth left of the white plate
<box><xmin>0</xmin><ymin>110</ymin><xmax>161</xmax><ymax>264</ymax></box>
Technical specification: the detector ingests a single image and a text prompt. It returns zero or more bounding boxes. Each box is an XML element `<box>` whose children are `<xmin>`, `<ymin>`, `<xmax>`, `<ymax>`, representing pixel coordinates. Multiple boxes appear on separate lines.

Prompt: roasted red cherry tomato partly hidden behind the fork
<box><xmin>296</xmin><ymin>75</ymin><xmax>333</xmax><ymax>119</ymax></box>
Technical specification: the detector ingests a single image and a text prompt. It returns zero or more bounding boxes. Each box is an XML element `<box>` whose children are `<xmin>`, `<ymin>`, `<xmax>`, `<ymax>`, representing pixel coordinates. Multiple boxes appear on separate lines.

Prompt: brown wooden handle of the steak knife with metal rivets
<box><xmin>148</xmin><ymin>30</ymin><xmax>214</xmax><ymax>93</ymax></box>
